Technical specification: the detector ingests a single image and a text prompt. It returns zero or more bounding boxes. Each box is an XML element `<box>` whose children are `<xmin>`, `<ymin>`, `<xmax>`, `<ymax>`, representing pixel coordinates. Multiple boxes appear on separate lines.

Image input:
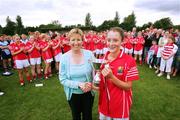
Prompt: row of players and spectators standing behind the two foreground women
<box><xmin>0</xmin><ymin>28</ymin><xmax>180</xmax><ymax>85</ymax></box>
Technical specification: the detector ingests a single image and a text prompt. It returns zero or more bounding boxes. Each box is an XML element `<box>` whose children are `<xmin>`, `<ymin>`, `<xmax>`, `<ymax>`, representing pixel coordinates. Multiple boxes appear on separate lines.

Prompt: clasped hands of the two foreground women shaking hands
<box><xmin>78</xmin><ymin>82</ymin><xmax>92</xmax><ymax>93</ymax></box>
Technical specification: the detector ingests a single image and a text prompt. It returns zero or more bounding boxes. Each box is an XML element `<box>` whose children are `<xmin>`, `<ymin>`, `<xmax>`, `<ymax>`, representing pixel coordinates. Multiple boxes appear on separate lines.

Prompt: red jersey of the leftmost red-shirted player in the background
<box><xmin>9</xmin><ymin>42</ymin><xmax>28</xmax><ymax>60</ymax></box>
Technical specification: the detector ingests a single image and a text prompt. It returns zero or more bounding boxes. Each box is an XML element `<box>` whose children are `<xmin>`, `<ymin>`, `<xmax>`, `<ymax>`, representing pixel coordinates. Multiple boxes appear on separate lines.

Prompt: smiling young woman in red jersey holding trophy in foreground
<box><xmin>96</xmin><ymin>27</ymin><xmax>139</xmax><ymax>120</ymax></box>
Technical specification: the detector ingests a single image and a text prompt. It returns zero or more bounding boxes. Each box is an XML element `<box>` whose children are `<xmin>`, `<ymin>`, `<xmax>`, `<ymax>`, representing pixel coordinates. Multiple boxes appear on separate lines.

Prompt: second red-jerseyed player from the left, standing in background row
<box><xmin>25</xmin><ymin>36</ymin><xmax>42</xmax><ymax>80</ymax></box>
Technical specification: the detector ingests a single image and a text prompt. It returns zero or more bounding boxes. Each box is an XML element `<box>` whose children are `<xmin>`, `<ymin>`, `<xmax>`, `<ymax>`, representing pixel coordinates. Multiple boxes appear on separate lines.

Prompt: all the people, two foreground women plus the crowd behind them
<box><xmin>0</xmin><ymin>27</ymin><xmax>180</xmax><ymax>120</ymax></box>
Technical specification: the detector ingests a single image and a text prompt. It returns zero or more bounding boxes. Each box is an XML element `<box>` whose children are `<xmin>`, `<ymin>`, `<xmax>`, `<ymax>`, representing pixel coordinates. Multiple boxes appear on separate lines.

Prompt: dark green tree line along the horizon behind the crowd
<box><xmin>0</xmin><ymin>11</ymin><xmax>180</xmax><ymax>35</ymax></box>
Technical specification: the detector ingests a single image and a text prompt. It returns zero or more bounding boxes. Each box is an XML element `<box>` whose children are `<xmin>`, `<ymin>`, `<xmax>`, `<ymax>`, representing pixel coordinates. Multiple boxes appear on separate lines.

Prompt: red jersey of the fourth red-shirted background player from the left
<box><xmin>51</xmin><ymin>39</ymin><xmax>61</xmax><ymax>56</ymax></box>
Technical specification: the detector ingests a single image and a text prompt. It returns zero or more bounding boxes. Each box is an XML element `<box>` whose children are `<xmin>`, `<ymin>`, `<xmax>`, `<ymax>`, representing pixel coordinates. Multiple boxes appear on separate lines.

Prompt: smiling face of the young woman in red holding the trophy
<box><xmin>107</xmin><ymin>31</ymin><xmax>122</xmax><ymax>53</ymax></box>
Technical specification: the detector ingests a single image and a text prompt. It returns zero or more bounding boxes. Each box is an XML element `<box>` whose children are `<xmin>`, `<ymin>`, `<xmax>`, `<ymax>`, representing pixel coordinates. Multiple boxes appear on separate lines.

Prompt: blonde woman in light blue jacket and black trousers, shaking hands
<box><xmin>59</xmin><ymin>28</ymin><xmax>94</xmax><ymax>120</ymax></box>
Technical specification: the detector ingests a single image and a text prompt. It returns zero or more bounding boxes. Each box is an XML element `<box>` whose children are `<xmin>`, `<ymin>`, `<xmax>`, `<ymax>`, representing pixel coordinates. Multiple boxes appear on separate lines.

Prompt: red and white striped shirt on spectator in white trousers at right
<box><xmin>162</xmin><ymin>43</ymin><xmax>178</xmax><ymax>57</ymax></box>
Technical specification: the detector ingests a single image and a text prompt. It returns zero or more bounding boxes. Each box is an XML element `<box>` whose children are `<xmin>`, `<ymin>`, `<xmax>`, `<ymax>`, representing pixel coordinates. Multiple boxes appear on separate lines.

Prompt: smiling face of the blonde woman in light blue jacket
<box><xmin>69</xmin><ymin>33</ymin><xmax>83</xmax><ymax>51</ymax></box>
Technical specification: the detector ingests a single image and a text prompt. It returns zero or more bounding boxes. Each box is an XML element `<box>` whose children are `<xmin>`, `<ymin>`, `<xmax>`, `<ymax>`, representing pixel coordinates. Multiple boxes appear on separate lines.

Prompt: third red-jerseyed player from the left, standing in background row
<box><xmin>39</xmin><ymin>34</ymin><xmax>53</xmax><ymax>79</ymax></box>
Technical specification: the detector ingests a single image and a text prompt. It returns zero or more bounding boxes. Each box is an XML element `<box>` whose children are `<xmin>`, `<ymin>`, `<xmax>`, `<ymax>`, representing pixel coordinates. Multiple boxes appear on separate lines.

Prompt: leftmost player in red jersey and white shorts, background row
<box><xmin>9</xmin><ymin>36</ymin><xmax>32</xmax><ymax>86</ymax></box>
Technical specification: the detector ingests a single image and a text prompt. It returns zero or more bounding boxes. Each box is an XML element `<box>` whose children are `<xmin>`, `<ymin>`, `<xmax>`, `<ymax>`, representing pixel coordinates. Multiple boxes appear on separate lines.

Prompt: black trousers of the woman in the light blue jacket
<box><xmin>68</xmin><ymin>92</ymin><xmax>94</xmax><ymax>120</ymax></box>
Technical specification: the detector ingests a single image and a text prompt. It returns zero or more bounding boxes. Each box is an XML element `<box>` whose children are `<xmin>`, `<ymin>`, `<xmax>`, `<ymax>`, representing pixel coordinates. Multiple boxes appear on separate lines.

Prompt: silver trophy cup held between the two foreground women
<box><xmin>92</xmin><ymin>59</ymin><xmax>104</xmax><ymax>86</ymax></box>
